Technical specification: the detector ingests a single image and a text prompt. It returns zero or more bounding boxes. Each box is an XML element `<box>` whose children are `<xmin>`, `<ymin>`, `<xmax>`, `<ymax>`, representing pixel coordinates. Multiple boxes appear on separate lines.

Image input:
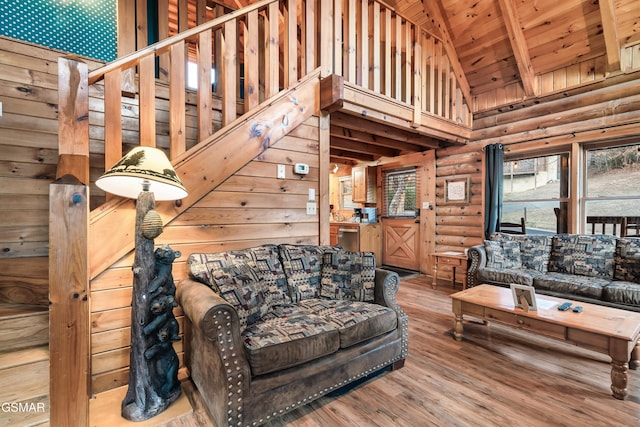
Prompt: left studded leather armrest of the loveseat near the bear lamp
<box><xmin>176</xmin><ymin>279</ymin><xmax>251</xmax><ymax>419</ymax></box>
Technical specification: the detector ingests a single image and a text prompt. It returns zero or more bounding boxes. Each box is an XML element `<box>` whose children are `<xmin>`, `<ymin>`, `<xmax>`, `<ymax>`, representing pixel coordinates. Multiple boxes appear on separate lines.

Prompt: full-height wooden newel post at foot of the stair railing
<box><xmin>49</xmin><ymin>58</ymin><xmax>90</xmax><ymax>426</ymax></box>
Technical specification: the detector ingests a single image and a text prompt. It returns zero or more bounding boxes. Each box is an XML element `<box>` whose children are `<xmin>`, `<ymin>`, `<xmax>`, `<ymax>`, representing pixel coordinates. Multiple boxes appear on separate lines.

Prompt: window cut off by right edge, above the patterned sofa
<box><xmin>583</xmin><ymin>144</ymin><xmax>640</xmax><ymax>235</ymax></box>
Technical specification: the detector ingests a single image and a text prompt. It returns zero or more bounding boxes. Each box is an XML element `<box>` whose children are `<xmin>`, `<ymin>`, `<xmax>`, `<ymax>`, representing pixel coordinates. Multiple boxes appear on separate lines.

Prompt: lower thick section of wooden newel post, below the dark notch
<box><xmin>49</xmin><ymin>175</ymin><xmax>91</xmax><ymax>427</ymax></box>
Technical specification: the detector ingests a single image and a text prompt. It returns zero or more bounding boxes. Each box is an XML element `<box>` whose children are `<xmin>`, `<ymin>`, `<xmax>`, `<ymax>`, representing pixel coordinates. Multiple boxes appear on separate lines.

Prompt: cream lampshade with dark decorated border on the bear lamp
<box><xmin>96</xmin><ymin>146</ymin><xmax>187</xmax><ymax>200</ymax></box>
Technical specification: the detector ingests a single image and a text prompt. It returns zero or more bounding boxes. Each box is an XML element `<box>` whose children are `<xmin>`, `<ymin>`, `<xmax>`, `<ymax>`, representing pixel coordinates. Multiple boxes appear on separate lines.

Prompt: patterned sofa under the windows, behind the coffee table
<box><xmin>467</xmin><ymin>233</ymin><xmax>640</xmax><ymax>311</ymax></box>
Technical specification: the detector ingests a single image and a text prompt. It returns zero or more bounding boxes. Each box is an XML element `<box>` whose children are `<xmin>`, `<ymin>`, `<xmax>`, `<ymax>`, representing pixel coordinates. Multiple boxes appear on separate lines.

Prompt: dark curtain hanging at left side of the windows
<box><xmin>484</xmin><ymin>144</ymin><xmax>504</xmax><ymax>239</ymax></box>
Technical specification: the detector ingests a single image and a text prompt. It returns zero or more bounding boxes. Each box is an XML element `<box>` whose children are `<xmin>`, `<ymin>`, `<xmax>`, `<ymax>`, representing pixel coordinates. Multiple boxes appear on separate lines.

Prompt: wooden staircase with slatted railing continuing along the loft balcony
<box><xmin>46</xmin><ymin>0</ymin><xmax>470</xmax><ymax>425</ymax></box>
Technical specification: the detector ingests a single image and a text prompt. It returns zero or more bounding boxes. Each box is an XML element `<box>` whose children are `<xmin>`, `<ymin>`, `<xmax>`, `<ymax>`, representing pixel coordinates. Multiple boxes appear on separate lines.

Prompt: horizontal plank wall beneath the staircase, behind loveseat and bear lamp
<box><xmin>91</xmin><ymin>117</ymin><xmax>320</xmax><ymax>393</ymax></box>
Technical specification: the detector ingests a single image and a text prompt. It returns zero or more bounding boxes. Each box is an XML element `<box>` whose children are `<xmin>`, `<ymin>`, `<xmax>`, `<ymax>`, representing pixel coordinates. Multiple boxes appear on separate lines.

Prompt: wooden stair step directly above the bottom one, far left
<box><xmin>0</xmin><ymin>304</ymin><xmax>49</xmax><ymax>352</ymax></box>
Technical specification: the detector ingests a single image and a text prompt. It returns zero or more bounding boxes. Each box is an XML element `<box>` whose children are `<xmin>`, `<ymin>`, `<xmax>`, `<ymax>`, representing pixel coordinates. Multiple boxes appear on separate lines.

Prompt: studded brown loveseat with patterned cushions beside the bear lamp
<box><xmin>177</xmin><ymin>245</ymin><xmax>408</xmax><ymax>426</ymax></box>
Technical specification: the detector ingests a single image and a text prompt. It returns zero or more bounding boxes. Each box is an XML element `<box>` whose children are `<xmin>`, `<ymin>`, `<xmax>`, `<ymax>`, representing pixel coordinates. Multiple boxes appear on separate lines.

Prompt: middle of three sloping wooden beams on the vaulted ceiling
<box><xmin>498</xmin><ymin>0</ymin><xmax>537</xmax><ymax>96</ymax></box>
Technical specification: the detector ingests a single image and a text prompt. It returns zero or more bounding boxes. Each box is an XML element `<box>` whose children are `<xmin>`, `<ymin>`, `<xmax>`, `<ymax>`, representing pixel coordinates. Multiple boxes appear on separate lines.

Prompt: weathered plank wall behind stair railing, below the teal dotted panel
<box><xmin>0</xmin><ymin>37</ymin><xmax>221</xmax><ymax>306</ymax></box>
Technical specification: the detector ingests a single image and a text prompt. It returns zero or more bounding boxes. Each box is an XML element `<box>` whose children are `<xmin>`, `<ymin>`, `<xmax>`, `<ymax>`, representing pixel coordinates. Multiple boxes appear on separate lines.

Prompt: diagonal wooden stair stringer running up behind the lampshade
<box><xmin>89</xmin><ymin>69</ymin><xmax>320</xmax><ymax>279</ymax></box>
